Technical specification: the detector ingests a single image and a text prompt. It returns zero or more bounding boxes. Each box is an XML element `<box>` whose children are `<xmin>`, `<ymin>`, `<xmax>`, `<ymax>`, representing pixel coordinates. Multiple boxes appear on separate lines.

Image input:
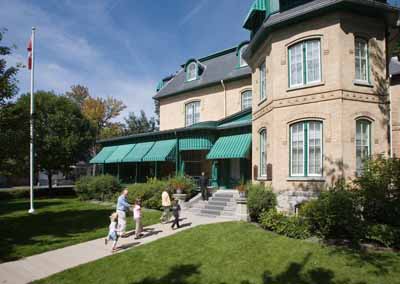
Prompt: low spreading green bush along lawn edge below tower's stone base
<box><xmin>260</xmin><ymin>209</ymin><xmax>311</xmax><ymax>239</ymax></box>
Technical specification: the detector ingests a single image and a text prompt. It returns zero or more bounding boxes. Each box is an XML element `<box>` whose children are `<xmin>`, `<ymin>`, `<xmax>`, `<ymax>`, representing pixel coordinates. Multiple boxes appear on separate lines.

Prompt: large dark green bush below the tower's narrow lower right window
<box><xmin>300</xmin><ymin>189</ymin><xmax>364</xmax><ymax>242</ymax></box>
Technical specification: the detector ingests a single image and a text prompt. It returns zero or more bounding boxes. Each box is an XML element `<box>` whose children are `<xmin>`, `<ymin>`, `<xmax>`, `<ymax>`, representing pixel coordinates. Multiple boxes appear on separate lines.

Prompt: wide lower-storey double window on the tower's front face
<box><xmin>290</xmin><ymin>121</ymin><xmax>322</xmax><ymax>176</ymax></box>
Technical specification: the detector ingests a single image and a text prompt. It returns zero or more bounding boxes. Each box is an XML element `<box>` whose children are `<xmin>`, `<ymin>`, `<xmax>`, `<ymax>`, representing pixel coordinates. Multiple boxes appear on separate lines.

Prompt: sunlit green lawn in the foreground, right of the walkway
<box><xmin>35</xmin><ymin>222</ymin><xmax>400</xmax><ymax>284</ymax></box>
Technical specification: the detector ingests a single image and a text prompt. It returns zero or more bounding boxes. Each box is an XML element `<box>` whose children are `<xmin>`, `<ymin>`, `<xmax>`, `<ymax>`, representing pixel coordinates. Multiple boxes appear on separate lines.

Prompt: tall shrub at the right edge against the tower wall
<box><xmin>355</xmin><ymin>156</ymin><xmax>400</xmax><ymax>227</ymax></box>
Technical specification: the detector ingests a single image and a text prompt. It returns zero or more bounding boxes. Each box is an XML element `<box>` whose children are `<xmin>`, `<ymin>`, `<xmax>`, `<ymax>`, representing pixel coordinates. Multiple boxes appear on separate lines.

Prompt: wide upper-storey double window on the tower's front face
<box><xmin>289</xmin><ymin>39</ymin><xmax>321</xmax><ymax>87</ymax></box>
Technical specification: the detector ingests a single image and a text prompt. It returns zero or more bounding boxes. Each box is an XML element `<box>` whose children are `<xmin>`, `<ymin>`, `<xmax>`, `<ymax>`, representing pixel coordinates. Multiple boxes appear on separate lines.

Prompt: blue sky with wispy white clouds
<box><xmin>0</xmin><ymin>0</ymin><xmax>253</xmax><ymax>120</ymax></box>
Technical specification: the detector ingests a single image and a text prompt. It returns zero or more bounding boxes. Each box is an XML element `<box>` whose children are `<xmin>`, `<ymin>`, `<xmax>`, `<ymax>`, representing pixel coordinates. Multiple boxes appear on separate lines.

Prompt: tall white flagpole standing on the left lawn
<box><xmin>28</xmin><ymin>27</ymin><xmax>35</xmax><ymax>213</ymax></box>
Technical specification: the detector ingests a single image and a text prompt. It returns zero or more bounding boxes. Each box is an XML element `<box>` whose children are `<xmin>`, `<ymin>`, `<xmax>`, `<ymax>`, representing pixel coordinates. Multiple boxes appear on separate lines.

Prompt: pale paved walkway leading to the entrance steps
<box><xmin>0</xmin><ymin>210</ymin><xmax>227</xmax><ymax>284</ymax></box>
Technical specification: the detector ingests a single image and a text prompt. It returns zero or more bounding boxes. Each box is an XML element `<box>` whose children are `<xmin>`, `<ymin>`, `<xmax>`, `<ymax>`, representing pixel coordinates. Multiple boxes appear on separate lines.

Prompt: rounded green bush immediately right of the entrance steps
<box><xmin>247</xmin><ymin>184</ymin><xmax>277</xmax><ymax>221</ymax></box>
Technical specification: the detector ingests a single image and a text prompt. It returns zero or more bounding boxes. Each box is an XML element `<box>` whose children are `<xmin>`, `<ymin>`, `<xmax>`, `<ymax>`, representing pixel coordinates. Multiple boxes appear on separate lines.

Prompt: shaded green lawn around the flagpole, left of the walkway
<box><xmin>0</xmin><ymin>198</ymin><xmax>161</xmax><ymax>262</ymax></box>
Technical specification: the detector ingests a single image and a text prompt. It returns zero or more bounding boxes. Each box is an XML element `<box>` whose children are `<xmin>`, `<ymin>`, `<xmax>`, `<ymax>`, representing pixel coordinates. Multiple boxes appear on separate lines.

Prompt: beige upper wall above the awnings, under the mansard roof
<box><xmin>160</xmin><ymin>76</ymin><xmax>251</xmax><ymax>130</ymax></box>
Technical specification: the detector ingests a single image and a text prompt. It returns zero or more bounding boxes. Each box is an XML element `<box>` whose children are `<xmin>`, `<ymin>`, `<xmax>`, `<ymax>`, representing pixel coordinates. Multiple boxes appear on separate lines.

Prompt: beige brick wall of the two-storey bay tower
<box><xmin>249</xmin><ymin>12</ymin><xmax>390</xmax><ymax>210</ymax></box>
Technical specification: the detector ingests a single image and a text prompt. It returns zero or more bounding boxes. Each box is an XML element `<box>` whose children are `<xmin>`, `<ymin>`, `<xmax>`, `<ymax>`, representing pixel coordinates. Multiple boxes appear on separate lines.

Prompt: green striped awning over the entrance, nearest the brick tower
<box><xmin>207</xmin><ymin>133</ymin><xmax>251</xmax><ymax>160</ymax></box>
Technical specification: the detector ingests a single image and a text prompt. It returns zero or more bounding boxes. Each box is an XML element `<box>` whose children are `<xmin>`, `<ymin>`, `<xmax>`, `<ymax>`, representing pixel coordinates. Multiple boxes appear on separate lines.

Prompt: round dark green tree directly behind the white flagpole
<box><xmin>14</xmin><ymin>91</ymin><xmax>95</xmax><ymax>189</ymax></box>
